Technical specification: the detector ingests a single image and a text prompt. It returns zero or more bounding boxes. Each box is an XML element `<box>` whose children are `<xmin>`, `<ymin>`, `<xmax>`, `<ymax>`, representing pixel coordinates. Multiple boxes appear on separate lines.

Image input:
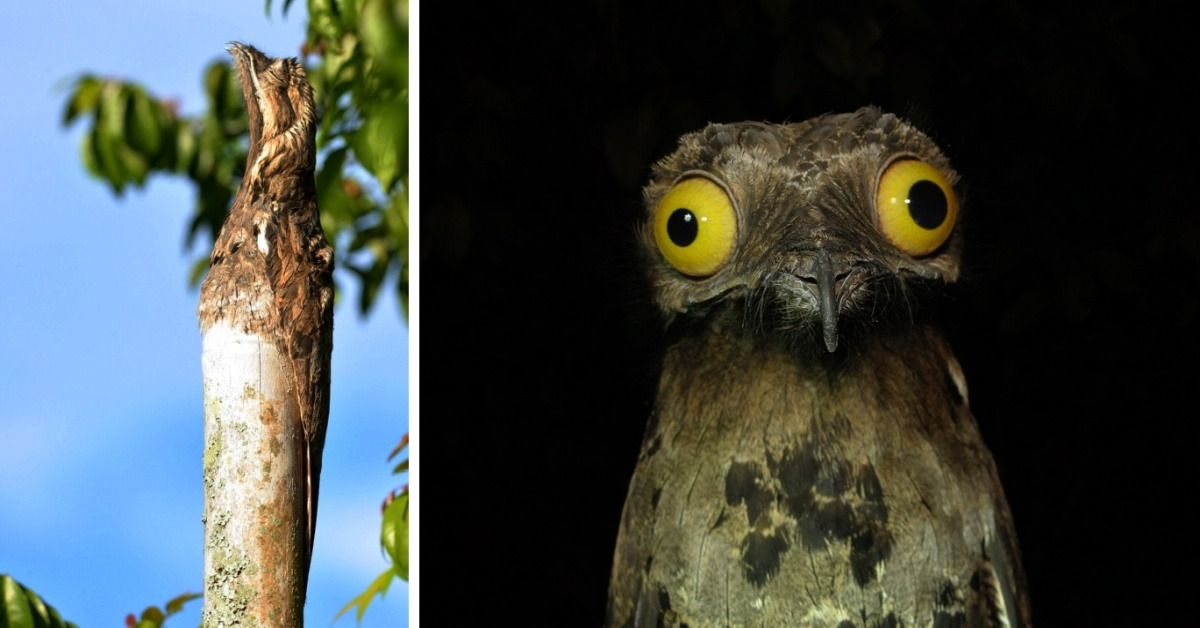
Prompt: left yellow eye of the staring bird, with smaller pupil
<box><xmin>654</xmin><ymin>177</ymin><xmax>738</xmax><ymax>277</ymax></box>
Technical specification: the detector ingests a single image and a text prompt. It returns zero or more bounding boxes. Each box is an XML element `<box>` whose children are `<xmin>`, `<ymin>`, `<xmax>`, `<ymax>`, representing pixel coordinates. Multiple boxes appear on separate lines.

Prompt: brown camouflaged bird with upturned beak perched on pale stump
<box><xmin>199</xmin><ymin>43</ymin><xmax>334</xmax><ymax>581</ymax></box>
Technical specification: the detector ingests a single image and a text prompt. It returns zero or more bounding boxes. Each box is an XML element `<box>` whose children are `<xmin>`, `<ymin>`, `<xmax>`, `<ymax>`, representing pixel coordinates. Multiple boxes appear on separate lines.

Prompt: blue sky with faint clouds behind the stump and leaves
<box><xmin>0</xmin><ymin>0</ymin><xmax>408</xmax><ymax>628</ymax></box>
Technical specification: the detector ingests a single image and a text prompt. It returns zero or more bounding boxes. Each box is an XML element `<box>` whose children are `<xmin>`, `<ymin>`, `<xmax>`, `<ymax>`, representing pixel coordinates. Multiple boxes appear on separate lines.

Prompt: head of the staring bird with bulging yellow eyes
<box><xmin>642</xmin><ymin>108</ymin><xmax>962</xmax><ymax>352</ymax></box>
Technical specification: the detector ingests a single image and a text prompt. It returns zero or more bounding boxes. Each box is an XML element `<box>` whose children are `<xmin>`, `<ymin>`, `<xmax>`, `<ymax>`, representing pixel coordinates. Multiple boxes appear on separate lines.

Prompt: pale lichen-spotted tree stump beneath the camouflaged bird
<box><xmin>200</xmin><ymin>321</ymin><xmax>308</xmax><ymax>626</ymax></box>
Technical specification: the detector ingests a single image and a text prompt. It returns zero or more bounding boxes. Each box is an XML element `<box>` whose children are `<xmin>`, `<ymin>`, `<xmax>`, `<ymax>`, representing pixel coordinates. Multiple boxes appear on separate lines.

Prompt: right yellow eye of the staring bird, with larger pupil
<box><xmin>875</xmin><ymin>160</ymin><xmax>959</xmax><ymax>257</ymax></box>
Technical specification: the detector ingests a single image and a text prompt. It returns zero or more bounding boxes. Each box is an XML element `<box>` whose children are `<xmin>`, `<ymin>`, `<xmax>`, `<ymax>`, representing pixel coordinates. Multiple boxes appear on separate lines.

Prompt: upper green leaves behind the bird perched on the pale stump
<box><xmin>62</xmin><ymin>0</ymin><xmax>408</xmax><ymax>313</ymax></box>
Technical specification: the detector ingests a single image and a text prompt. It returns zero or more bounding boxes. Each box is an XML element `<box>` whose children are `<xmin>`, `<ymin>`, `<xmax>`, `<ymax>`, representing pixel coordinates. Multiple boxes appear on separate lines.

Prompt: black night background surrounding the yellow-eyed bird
<box><xmin>419</xmin><ymin>0</ymin><xmax>1200</xmax><ymax>626</ymax></box>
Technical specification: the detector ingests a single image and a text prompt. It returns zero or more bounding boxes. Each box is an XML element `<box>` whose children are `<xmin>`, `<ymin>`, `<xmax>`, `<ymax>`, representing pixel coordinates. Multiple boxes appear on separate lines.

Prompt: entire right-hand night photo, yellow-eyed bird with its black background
<box><xmin>418</xmin><ymin>0</ymin><xmax>1200</xmax><ymax>628</ymax></box>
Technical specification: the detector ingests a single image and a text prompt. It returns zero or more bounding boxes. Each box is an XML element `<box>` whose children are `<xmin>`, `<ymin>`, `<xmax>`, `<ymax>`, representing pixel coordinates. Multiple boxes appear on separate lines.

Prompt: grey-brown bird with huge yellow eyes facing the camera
<box><xmin>607</xmin><ymin>108</ymin><xmax>1030</xmax><ymax>627</ymax></box>
